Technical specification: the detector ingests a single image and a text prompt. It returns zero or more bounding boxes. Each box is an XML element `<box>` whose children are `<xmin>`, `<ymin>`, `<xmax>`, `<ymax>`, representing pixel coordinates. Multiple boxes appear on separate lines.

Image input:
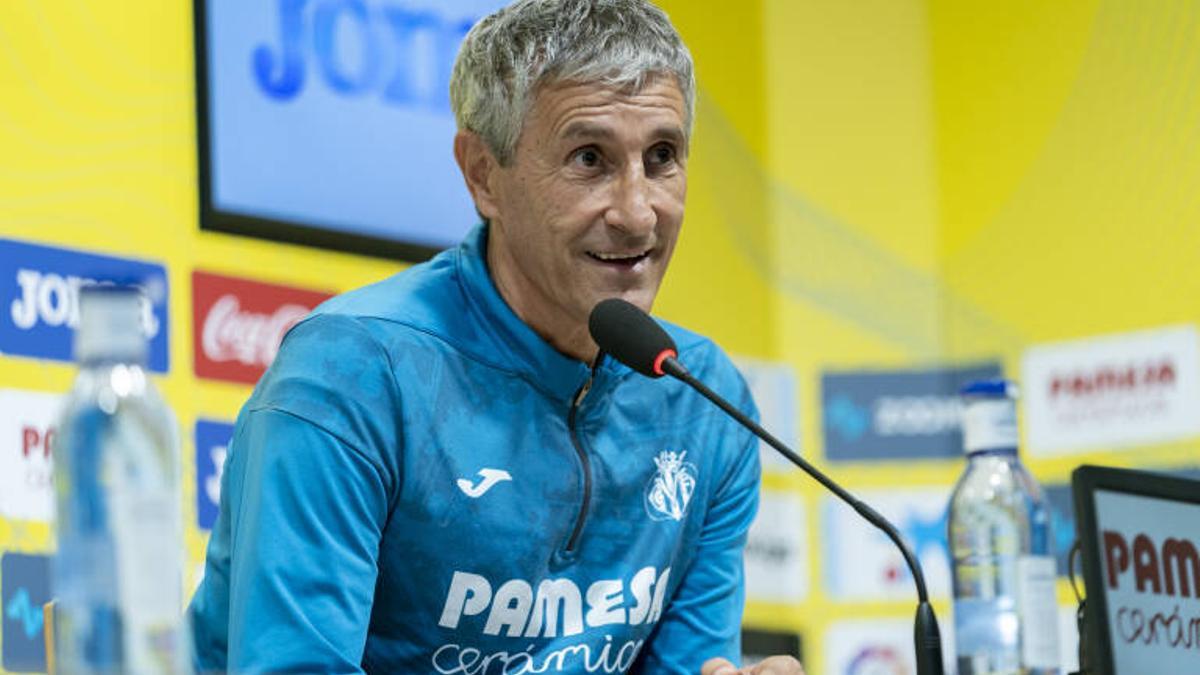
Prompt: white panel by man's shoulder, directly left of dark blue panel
<box><xmin>733</xmin><ymin>357</ymin><xmax>800</xmax><ymax>472</ymax></box>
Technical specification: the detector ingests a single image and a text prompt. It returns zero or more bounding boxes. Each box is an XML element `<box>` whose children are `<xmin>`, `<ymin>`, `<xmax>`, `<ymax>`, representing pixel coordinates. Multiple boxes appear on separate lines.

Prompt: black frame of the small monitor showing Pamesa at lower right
<box><xmin>1070</xmin><ymin>465</ymin><xmax>1200</xmax><ymax>675</ymax></box>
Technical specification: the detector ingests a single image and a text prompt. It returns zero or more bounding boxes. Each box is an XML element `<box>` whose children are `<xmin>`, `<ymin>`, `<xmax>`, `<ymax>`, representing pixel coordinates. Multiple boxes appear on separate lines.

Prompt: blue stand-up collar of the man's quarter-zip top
<box><xmin>456</xmin><ymin>223</ymin><xmax>631</xmax><ymax>405</ymax></box>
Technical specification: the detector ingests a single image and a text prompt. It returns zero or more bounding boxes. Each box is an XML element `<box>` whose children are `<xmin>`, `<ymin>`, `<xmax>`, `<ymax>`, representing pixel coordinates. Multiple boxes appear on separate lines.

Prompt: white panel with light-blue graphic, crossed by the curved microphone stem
<box><xmin>822</xmin><ymin>486</ymin><xmax>950</xmax><ymax>601</ymax></box>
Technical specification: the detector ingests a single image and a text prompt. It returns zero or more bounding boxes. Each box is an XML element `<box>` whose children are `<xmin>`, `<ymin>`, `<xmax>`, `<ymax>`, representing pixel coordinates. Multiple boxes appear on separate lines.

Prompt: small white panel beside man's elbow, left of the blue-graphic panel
<box><xmin>745</xmin><ymin>491</ymin><xmax>809</xmax><ymax>603</ymax></box>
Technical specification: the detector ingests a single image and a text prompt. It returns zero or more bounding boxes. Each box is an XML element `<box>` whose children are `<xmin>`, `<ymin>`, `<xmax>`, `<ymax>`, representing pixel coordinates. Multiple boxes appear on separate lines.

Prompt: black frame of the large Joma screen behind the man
<box><xmin>192</xmin><ymin>0</ymin><xmax>443</xmax><ymax>263</ymax></box>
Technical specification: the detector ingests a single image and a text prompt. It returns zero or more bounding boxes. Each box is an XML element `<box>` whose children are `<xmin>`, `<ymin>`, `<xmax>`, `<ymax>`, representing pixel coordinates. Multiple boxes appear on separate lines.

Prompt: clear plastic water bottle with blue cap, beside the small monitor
<box><xmin>949</xmin><ymin>380</ymin><xmax>1058</xmax><ymax>675</ymax></box>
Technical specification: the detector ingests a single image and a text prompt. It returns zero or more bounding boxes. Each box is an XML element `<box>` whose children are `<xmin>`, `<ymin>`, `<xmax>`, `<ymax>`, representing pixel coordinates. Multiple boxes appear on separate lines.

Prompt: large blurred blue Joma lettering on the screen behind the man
<box><xmin>251</xmin><ymin>0</ymin><xmax>475</xmax><ymax>112</ymax></box>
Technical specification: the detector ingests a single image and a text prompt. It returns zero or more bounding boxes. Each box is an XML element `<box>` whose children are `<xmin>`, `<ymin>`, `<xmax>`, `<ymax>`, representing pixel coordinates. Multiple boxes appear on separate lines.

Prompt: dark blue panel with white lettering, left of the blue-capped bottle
<box><xmin>821</xmin><ymin>363</ymin><xmax>1002</xmax><ymax>461</ymax></box>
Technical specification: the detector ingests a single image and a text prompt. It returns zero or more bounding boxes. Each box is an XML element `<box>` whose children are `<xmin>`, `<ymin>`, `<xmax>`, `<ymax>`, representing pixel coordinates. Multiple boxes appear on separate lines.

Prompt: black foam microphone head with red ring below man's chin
<box><xmin>588</xmin><ymin>298</ymin><xmax>678</xmax><ymax>377</ymax></box>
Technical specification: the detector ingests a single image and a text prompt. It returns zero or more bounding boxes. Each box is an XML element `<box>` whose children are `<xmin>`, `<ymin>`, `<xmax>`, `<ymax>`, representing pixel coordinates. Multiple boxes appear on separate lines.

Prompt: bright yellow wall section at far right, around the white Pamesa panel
<box><xmin>930</xmin><ymin>0</ymin><xmax>1200</xmax><ymax>470</ymax></box>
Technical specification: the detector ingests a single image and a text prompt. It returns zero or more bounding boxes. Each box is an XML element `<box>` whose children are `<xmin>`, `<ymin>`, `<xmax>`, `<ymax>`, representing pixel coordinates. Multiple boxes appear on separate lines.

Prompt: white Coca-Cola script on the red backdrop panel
<box><xmin>200</xmin><ymin>294</ymin><xmax>311</xmax><ymax>368</ymax></box>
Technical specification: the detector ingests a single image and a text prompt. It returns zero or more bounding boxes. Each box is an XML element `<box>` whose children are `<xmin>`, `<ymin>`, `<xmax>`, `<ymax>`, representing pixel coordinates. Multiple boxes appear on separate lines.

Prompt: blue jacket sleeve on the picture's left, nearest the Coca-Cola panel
<box><xmin>192</xmin><ymin>317</ymin><xmax>400</xmax><ymax>673</ymax></box>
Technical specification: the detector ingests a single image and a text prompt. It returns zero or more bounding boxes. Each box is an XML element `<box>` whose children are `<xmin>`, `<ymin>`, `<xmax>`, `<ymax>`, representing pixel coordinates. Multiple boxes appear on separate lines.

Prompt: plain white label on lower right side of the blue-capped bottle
<box><xmin>1016</xmin><ymin>555</ymin><xmax>1058</xmax><ymax>668</ymax></box>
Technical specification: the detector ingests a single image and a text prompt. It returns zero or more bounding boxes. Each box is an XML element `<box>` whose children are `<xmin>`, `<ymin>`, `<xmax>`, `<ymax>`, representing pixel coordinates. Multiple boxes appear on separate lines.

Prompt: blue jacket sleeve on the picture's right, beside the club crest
<box><xmin>631</xmin><ymin>369</ymin><xmax>760</xmax><ymax>675</ymax></box>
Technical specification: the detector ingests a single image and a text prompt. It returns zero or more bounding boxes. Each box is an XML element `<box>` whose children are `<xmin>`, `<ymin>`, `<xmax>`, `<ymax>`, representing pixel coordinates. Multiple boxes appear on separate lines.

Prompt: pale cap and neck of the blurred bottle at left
<box><xmin>74</xmin><ymin>283</ymin><xmax>146</xmax><ymax>362</ymax></box>
